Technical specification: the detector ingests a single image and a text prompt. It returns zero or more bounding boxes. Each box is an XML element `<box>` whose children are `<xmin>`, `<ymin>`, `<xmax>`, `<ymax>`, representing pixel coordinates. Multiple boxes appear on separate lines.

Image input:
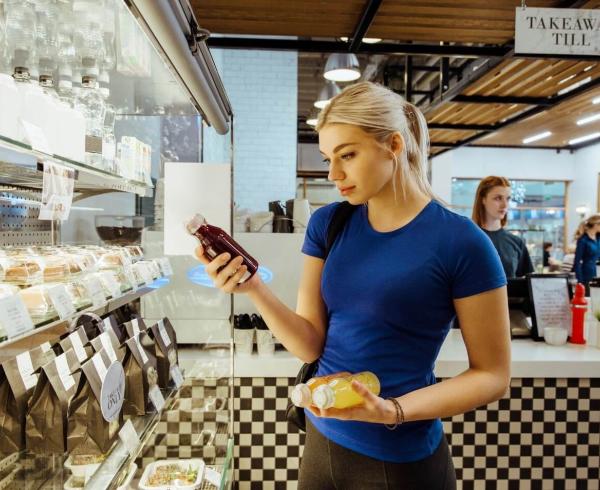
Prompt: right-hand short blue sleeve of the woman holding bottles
<box><xmin>448</xmin><ymin>221</ymin><xmax>506</xmax><ymax>299</ymax></box>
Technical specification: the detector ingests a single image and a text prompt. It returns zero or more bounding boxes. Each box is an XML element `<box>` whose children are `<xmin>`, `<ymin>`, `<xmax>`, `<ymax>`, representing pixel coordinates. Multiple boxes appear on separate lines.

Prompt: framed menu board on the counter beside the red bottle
<box><xmin>528</xmin><ymin>274</ymin><xmax>571</xmax><ymax>339</ymax></box>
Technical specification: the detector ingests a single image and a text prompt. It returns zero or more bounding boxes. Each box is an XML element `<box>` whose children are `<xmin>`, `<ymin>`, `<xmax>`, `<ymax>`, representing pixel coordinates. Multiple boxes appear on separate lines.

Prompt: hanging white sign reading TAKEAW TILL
<box><xmin>515</xmin><ymin>7</ymin><xmax>600</xmax><ymax>56</ymax></box>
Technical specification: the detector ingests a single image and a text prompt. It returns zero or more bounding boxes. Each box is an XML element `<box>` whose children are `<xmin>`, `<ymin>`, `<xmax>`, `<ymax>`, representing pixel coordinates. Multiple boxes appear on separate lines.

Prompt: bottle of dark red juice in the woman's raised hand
<box><xmin>186</xmin><ymin>214</ymin><xmax>258</xmax><ymax>282</ymax></box>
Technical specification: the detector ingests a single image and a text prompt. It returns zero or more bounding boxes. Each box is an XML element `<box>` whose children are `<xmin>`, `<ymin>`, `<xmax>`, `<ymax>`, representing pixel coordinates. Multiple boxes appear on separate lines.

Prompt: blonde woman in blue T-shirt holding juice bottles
<box><xmin>197</xmin><ymin>82</ymin><xmax>510</xmax><ymax>490</ymax></box>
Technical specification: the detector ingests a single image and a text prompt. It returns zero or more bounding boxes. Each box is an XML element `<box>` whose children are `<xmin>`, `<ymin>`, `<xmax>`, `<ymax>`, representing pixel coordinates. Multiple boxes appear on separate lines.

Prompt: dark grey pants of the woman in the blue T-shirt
<box><xmin>298</xmin><ymin>417</ymin><xmax>456</xmax><ymax>490</ymax></box>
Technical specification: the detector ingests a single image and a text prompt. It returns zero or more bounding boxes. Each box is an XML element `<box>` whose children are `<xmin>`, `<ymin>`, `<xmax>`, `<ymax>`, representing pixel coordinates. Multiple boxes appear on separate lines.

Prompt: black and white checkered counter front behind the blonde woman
<box><xmin>234</xmin><ymin>378</ymin><xmax>600</xmax><ymax>490</ymax></box>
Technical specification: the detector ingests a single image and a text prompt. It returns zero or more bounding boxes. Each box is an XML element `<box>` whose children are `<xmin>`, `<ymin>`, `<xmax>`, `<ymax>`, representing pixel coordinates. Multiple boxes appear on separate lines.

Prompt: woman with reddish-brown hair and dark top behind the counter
<box><xmin>473</xmin><ymin>175</ymin><xmax>534</xmax><ymax>278</ymax></box>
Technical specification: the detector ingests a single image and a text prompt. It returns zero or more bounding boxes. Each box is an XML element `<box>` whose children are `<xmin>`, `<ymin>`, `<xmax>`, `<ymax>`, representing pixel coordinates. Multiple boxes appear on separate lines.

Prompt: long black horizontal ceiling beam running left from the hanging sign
<box><xmin>207</xmin><ymin>37</ymin><xmax>510</xmax><ymax>58</ymax></box>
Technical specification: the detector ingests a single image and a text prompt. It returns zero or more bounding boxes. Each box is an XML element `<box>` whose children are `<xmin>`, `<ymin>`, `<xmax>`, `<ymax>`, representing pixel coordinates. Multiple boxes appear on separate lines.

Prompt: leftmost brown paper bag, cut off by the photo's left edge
<box><xmin>0</xmin><ymin>344</ymin><xmax>54</xmax><ymax>455</ymax></box>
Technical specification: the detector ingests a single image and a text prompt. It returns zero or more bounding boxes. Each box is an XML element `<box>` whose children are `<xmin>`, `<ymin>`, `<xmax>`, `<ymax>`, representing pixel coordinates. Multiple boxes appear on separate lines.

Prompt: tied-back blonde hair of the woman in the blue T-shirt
<box><xmin>315</xmin><ymin>82</ymin><xmax>435</xmax><ymax>199</ymax></box>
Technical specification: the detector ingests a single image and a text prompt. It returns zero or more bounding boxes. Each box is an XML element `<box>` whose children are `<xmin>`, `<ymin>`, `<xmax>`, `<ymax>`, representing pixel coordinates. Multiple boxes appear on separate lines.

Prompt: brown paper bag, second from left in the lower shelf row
<box><xmin>25</xmin><ymin>349</ymin><xmax>81</xmax><ymax>454</ymax></box>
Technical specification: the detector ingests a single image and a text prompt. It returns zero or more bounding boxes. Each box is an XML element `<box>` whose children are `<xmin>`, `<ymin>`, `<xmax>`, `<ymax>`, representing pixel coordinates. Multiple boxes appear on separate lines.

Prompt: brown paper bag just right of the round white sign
<box><xmin>123</xmin><ymin>332</ymin><xmax>158</xmax><ymax>415</ymax></box>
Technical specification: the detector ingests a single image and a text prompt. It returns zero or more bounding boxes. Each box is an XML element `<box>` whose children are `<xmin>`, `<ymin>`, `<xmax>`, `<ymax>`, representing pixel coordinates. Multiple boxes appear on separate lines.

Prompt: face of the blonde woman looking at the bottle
<box><xmin>319</xmin><ymin>124</ymin><xmax>402</xmax><ymax>204</ymax></box>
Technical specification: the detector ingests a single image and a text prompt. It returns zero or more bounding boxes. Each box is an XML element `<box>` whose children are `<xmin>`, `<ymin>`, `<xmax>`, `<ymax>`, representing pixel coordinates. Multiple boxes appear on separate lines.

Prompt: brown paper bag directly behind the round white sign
<box><xmin>67</xmin><ymin>350</ymin><xmax>123</xmax><ymax>455</ymax></box>
